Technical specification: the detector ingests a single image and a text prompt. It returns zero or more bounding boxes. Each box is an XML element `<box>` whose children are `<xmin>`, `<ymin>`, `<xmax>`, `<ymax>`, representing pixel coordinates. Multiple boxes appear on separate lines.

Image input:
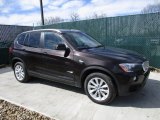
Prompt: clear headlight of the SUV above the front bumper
<box><xmin>119</xmin><ymin>63</ymin><xmax>137</xmax><ymax>72</ymax></box>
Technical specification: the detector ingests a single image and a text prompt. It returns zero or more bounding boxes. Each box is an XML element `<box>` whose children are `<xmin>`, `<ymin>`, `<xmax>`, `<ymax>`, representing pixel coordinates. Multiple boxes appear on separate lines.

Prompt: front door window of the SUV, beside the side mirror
<box><xmin>44</xmin><ymin>32</ymin><xmax>63</xmax><ymax>50</ymax></box>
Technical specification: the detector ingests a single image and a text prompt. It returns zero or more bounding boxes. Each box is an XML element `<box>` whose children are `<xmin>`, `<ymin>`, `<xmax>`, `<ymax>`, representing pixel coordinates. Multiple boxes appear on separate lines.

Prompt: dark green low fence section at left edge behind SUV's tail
<box><xmin>0</xmin><ymin>48</ymin><xmax>9</xmax><ymax>65</ymax></box>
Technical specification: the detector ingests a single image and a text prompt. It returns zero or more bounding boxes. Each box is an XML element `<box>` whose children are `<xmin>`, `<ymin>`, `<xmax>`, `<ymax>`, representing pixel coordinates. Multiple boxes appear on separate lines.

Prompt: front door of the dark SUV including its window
<box><xmin>42</xmin><ymin>32</ymin><xmax>74</xmax><ymax>82</ymax></box>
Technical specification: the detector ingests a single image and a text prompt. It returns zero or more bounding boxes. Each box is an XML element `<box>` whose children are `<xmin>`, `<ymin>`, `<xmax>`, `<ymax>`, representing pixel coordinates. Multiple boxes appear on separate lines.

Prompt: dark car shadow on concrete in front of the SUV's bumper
<box><xmin>110</xmin><ymin>79</ymin><xmax>160</xmax><ymax>108</ymax></box>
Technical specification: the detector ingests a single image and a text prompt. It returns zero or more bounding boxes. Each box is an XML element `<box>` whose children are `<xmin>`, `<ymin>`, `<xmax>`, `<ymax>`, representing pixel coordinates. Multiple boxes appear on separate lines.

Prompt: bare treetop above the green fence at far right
<box><xmin>141</xmin><ymin>3</ymin><xmax>160</xmax><ymax>14</ymax></box>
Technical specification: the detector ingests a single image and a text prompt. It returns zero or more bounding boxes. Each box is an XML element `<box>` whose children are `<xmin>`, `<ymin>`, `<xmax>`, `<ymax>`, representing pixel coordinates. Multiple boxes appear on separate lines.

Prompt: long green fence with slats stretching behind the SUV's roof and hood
<box><xmin>35</xmin><ymin>13</ymin><xmax>160</xmax><ymax>68</ymax></box>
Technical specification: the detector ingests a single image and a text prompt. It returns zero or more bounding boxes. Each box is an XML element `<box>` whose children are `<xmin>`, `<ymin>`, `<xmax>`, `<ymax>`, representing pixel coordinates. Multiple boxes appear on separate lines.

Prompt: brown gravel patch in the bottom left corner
<box><xmin>0</xmin><ymin>99</ymin><xmax>53</xmax><ymax>120</ymax></box>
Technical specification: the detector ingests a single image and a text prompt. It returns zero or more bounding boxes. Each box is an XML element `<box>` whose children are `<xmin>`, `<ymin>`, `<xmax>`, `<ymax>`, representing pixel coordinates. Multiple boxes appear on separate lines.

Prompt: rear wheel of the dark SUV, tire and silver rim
<box><xmin>14</xmin><ymin>62</ymin><xmax>29</xmax><ymax>83</ymax></box>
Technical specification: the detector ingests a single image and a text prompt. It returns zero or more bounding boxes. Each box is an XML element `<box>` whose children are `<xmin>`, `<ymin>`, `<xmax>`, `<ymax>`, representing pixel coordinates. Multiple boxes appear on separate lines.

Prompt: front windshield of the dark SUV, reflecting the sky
<box><xmin>63</xmin><ymin>32</ymin><xmax>102</xmax><ymax>49</ymax></box>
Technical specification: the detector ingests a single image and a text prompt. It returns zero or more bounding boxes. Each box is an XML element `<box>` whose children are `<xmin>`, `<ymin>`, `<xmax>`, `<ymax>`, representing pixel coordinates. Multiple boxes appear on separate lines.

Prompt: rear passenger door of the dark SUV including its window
<box><xmin>24</xmin><ymin>32</ymin><xmax>42</xmax><ymax>74</ymax></box>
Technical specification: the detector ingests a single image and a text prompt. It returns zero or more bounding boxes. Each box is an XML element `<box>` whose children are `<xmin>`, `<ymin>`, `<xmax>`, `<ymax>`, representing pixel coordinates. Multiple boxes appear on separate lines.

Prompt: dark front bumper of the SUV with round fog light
<box><xmin>116</xmin><ymin>70</ymin><xmax>150</xmax><ymax>96</ymax></box>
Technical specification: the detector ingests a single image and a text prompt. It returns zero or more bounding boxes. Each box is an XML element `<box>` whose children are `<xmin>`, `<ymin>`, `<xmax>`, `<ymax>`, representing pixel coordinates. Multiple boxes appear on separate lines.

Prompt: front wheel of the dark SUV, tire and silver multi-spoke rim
<box><xmin>84</xmin><ymin>73</ymin><xmax>117</xmax><ymax>104</ymax></box>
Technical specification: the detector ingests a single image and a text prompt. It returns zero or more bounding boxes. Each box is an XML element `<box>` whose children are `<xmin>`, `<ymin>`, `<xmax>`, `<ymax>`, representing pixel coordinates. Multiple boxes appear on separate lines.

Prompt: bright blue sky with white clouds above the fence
<box><xmin>0</xmin><ymin>0</ymin><xmax>160</xmax><ymax>26</ymax></box>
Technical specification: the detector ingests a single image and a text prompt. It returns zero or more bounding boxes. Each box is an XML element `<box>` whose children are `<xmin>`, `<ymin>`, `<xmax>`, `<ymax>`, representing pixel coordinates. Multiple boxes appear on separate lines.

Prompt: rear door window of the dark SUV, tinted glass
<box><xmin>25</xmin><ymin>32</ymin><xmax>41</xmax><ymax>48</ymax></box>
